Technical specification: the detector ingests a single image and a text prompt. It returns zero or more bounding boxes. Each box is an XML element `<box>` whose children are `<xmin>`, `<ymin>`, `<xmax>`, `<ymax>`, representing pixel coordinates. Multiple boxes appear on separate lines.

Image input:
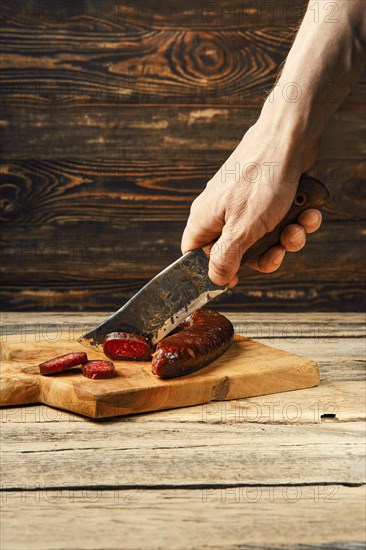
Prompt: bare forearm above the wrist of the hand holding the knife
<box><xmin>260</xmin><ymin>0</ymin><xmax>366</xmax><ymax>155</ymax></box>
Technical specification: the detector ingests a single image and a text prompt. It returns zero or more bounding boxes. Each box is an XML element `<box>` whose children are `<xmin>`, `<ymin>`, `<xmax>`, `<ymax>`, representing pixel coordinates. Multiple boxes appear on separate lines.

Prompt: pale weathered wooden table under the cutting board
<box><xmin>1</xmin><ymin>313</ymin><xmax>366</xmax><ymax>550</ymax></box>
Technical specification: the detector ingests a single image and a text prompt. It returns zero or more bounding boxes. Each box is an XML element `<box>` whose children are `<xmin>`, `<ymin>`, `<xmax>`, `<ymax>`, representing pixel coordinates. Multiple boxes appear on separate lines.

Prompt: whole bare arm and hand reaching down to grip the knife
<box><xmin>182</xmin><ymin>0</ymin><xmax>366</xmax><ymax>286</ymax></box>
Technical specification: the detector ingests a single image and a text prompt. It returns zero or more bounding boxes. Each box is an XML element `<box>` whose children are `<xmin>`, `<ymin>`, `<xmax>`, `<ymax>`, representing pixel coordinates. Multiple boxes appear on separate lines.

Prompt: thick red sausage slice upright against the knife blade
<box><xmin>103</xmin><ymin>332</ymin><xmax>152</xmax><ymax>361</ymax></box>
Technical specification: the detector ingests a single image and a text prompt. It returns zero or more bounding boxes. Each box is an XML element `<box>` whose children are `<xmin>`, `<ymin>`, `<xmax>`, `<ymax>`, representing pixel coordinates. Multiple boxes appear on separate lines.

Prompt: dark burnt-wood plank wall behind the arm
<box><xmin>0</xmin><ymin>0</ymin><xmax>366</xmax><ymax>311</ymax></box>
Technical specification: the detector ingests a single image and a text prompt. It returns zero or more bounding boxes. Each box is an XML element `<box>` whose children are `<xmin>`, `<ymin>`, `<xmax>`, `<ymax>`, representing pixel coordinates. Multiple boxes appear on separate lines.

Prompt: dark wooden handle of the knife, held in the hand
<box><xmin>242</xmin><ymin>175</ymin><xmax>329</xmax><ymax>262</ymax></box>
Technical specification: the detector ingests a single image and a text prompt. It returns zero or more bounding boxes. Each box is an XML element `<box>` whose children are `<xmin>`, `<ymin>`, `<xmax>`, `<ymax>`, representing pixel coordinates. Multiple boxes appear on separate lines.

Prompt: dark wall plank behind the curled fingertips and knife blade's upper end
<box><xmin>1</xmin><ymin>222</ymin><xmax>365</xmax><ymax>286</ymax></box>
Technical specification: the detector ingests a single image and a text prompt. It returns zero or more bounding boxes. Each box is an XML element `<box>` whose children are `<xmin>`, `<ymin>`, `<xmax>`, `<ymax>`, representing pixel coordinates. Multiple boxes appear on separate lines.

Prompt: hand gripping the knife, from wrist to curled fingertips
<box><xmin>182</xmin><ymin>121</ymin><xmax>322</xmax><ymax>287</ymax></box>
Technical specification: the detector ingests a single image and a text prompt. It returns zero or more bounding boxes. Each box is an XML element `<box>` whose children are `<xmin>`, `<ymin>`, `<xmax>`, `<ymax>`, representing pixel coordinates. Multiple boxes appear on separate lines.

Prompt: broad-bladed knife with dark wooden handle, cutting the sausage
<box><xmin>78</xmin><ymin>175</ymin><xmax>329</xmax><ymax>351</ymax></box>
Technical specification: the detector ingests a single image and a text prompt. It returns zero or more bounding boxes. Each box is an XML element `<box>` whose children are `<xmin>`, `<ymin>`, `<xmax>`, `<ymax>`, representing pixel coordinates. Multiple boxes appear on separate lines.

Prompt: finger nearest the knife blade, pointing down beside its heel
<box><xmin>208</xmin><ymin>225</ymin><xmax>243</xmax><ymax>285</ymax></box>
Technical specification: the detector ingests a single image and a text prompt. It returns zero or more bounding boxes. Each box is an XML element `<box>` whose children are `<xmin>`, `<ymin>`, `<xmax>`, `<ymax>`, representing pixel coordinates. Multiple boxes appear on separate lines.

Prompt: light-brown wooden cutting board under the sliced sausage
<box><xmin>0</xmin><ymin>334</ymin><xmax>319</xmax><ymax>418</ymax></box>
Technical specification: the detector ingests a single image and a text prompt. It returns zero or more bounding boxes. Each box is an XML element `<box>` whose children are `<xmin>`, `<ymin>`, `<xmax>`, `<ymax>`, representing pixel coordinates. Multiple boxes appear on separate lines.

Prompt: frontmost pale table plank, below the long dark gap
<box><xmin>1</xmin><ymin>485</ymin><xmax>365</xmax><ymax>550</ymax></box>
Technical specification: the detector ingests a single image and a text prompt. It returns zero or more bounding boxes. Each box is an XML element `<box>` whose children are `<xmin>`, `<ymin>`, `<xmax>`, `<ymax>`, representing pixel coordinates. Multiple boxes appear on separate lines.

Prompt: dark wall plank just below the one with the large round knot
<box><xmin>1</xmin><ymin>105</ymin><xmax>364</xmax><ymax>160</ymax></box>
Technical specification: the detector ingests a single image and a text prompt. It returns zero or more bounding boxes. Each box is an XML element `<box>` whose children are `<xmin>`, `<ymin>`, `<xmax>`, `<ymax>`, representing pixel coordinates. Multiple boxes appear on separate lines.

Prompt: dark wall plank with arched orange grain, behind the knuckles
<box><xmin>0</xmin><ymin>158</ymin><xmax>366</xmax><ymax>224</ymax></box>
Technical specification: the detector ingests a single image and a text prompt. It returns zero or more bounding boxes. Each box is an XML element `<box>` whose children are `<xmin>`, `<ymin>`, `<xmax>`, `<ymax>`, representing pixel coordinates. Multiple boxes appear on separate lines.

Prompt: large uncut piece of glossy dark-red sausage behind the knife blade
<box><xmin>152</xmin><ymin>309</ymin><xmax>234</xmax><ymax>378</ymax></box>
